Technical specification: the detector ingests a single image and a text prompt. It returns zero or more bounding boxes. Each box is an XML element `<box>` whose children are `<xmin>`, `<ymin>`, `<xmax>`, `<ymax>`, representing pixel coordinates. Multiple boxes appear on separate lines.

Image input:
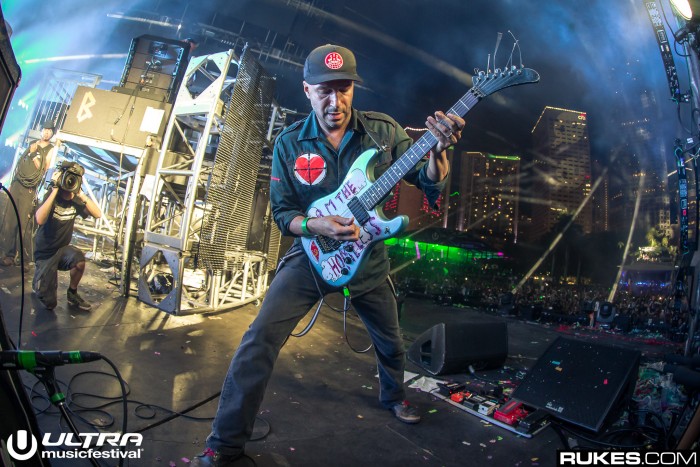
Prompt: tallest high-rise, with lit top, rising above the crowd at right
<box><xmin>524</xmin><ymin>106</ymin><xmax>593</xmax><ymax>240</ymax></box>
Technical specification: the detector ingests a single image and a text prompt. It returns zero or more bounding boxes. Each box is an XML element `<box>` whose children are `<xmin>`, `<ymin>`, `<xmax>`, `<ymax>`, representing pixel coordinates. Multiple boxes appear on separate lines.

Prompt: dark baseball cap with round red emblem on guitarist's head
<box><xmin>304</xmin><ymin>44</ymin><xmax>362</xmax><ymax>84</ymax></box>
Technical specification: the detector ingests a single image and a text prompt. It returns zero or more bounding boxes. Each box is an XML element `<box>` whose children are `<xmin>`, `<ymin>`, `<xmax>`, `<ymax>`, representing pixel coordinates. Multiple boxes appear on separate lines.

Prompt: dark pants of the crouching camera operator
<box><xmin>32</xmin><ymin>245</ymin><xmax>85</xmax><ymax>310</ymax></box>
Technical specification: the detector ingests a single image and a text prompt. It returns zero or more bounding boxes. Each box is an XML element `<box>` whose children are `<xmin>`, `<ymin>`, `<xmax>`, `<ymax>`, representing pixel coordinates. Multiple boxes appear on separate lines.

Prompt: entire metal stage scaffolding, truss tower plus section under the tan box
<box><xmin>37</xmin><ymin>49</ymin><xmax>296</xmax><ymax>314</ymax></box>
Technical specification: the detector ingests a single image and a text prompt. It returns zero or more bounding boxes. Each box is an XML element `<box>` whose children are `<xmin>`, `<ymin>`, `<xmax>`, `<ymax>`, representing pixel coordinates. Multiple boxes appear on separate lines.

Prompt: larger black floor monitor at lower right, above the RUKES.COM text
<box><xmin>512</xmin><ymin>337</ymin><xmax>640</xmax><ymax>432</ymax></box>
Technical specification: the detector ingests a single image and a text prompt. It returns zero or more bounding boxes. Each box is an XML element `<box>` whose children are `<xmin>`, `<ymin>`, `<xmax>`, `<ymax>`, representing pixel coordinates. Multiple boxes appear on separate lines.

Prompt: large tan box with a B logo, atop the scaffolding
<box><xmin>61</xmin><ymin>86</ymin><xmax>172</xmax><ymax>152</ymax></box>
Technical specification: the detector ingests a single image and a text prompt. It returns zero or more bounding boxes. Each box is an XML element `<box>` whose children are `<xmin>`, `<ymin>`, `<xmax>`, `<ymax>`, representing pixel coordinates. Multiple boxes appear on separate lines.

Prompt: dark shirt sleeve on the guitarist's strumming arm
<box><xmin>270</xmin><ymin>135</ymin><xmax>306</xmax><ymax>237</ymax></box>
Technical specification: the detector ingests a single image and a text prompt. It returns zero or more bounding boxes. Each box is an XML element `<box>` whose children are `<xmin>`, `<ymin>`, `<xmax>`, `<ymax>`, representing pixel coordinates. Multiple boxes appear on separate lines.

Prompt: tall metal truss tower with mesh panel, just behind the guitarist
<box><xmin>137</xmin><ymin>49</ymin><xmax>282</xmax><ymax>314</ymax></box>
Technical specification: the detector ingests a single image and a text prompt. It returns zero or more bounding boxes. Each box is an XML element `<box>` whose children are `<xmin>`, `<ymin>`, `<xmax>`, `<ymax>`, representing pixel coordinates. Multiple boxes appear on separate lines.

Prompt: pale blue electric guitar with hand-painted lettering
<box><xmin>301</xmin><ymin>66</ymin><xmax>540</xmax><ymax>287</ymax></box>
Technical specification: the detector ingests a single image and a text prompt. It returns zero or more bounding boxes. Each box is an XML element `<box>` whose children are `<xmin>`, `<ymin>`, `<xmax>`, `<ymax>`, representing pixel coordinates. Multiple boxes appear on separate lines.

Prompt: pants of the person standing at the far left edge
<box><xmin>0</xmin><ymin>180</ymin><xmax>36</xmax><ymax>262</ymax></box>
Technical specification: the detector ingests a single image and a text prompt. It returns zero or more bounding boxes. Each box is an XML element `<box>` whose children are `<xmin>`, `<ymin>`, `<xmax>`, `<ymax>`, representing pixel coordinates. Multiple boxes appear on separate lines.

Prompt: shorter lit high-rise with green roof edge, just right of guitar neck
<box><xmin>443</xmin><ymin>151</ymin><xmax>520</xmax><ymax>248</ymax></box>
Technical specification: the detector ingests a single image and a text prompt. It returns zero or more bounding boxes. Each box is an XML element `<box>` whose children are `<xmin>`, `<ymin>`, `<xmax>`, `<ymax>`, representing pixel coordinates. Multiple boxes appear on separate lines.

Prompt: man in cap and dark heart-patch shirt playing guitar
<box><xmin>191</xmin><ymin>45</ymin><xmax>464</xmax><ymax>466</ymax></box>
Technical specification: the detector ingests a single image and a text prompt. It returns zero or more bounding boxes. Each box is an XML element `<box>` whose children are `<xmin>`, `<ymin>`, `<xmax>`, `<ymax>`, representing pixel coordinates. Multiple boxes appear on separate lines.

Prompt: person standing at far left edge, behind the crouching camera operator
<box><xmin>0</xmin><ymin>120</ymin><xmax>61</xmax><ymax>266</ymax></box>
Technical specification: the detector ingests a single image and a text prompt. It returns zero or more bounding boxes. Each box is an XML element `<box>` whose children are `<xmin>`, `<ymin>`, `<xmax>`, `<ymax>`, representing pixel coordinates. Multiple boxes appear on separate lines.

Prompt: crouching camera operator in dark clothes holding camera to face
<box><xmin>32</xmin><ymin>161</ymin><xmax>102</xmax><ymax>310</ymax></box>
